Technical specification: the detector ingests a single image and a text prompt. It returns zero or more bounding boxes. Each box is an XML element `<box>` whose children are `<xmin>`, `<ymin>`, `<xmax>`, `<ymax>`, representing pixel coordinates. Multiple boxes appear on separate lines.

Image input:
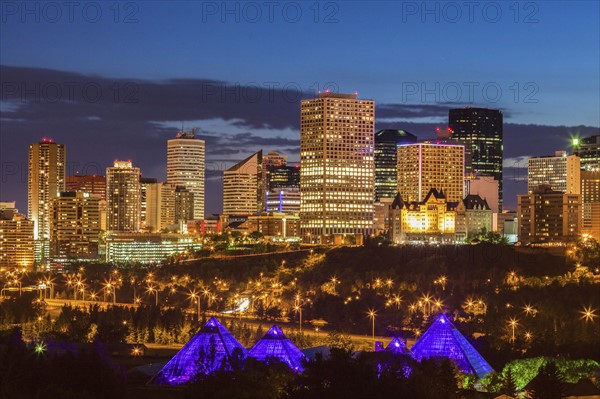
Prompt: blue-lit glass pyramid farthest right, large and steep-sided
<box><xmin>411</xmin><ymin>315</ymin><xmax>494</xmax><ymax>378</ymax></box>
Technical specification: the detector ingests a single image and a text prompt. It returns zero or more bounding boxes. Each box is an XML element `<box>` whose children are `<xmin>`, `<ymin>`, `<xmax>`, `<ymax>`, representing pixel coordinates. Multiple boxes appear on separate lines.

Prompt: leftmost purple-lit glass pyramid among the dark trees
<box><xmin>150</xmin><ymin>317</ymin><xmax>246</xmax><ymax>385</ymax></box>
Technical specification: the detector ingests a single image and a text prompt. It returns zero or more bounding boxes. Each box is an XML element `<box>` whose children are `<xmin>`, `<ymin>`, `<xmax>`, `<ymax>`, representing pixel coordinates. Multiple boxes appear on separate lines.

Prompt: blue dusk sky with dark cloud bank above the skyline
<box><xmin>0</xmin><ymin>1</ymin><xmax>600</xmax><ymax>213</ymax></box>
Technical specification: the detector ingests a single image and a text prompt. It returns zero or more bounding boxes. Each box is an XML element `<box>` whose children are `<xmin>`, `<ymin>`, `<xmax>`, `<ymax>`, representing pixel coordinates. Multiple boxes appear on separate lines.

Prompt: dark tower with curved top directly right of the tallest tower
<box><xmin>375</xmin><ymin>129</ymin><xmax>417</xmax><ymax>201</ymax></box>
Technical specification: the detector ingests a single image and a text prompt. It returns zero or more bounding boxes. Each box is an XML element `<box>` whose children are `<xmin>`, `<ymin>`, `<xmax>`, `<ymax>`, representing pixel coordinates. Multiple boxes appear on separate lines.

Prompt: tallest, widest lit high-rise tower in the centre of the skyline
<box><xmin>300</xmin><ymin>92</ymin><xmax>375</xmax><ymax>241</ymax></box>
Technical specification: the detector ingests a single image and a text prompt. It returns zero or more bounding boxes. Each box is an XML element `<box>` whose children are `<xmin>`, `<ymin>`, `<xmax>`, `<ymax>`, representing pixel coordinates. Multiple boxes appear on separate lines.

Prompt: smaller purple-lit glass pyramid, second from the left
<box><xmin>248</xmin><ymin>326</ymin><xmax>304</xmax><ymax>371</ymax></box>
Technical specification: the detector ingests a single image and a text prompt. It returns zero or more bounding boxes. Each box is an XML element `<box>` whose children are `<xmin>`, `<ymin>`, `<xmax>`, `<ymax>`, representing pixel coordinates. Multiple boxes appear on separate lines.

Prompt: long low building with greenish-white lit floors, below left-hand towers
<box><xmin>106</xmin><ymin>233</ymin><xmax>202</xmax><ymax>264</ymax></box>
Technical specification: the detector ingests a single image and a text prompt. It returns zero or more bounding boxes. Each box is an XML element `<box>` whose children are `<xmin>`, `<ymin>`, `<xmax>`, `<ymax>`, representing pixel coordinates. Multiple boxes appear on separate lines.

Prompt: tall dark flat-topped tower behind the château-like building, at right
<box><xmin>448</xmin><ymin>108</ymin><xmax>504</xmax><ymax>212</ymax></box>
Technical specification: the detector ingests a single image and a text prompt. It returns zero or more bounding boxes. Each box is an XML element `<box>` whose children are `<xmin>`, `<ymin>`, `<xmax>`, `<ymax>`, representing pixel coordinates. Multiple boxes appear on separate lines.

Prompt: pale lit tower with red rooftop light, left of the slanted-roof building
<box><xmin>167</xmin><ymin>131</ymin><xmax>206</xmax><ymax>220</ymax></box>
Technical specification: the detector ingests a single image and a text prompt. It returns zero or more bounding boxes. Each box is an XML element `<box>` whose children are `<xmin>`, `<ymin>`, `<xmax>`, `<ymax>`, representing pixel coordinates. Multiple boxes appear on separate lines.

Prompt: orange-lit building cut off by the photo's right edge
<box><xmin>581</xmin><ymin>169</ymin><xmax>600</xmax><ymax>240</ymax></box>
